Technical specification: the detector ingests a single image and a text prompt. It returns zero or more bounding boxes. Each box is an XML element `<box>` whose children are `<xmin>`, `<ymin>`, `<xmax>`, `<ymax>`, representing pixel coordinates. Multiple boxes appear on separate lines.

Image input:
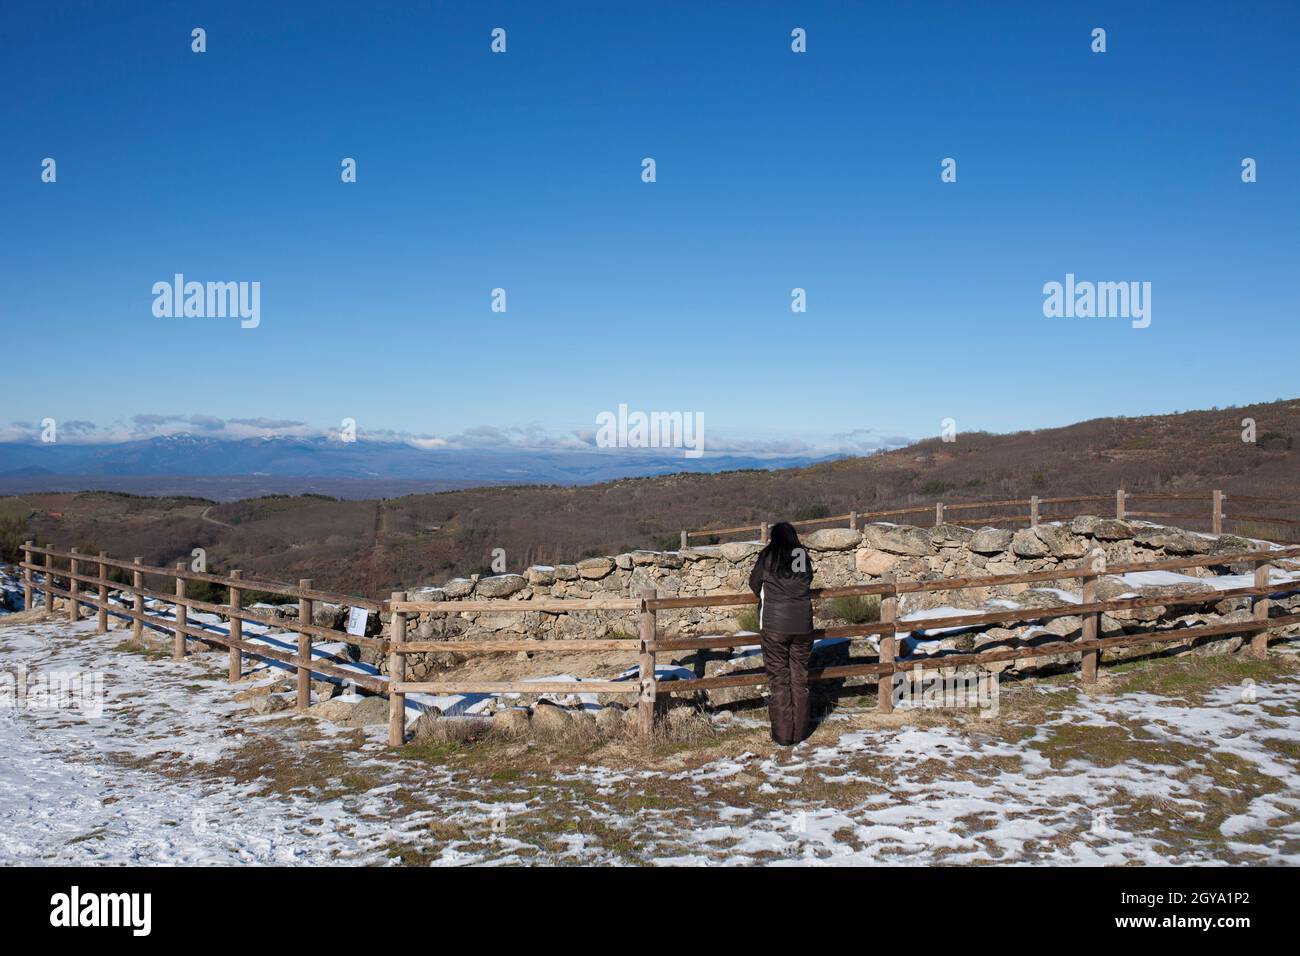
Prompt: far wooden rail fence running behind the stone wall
<box><xmin>681</xmin><ymin>488</ymin><xmax>1300</xmax><ymax>548</ymax></box>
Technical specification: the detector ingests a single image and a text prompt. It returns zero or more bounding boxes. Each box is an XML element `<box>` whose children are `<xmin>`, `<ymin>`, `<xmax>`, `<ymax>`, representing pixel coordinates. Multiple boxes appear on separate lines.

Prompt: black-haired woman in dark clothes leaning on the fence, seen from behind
<box><xmin>749</xmin><ymin>522</ymin><xmax>813</xmax><ymax>747</ymax></box>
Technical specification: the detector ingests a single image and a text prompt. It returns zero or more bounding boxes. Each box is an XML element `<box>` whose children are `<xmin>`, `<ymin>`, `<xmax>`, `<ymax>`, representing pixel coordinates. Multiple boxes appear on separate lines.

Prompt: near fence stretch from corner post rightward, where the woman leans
<box><xmin>389</xmin><ymin>548</ymin><xmax>1300</xmax><ymax>745</ymax></box>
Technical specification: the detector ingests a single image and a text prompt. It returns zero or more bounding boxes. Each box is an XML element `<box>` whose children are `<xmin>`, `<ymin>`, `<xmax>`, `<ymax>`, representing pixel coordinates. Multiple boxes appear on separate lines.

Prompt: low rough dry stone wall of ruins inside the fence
<box><xmin>369</xmin><ymin>515</ymin><xmax>1300</xmax><ymax>680</ymax></box>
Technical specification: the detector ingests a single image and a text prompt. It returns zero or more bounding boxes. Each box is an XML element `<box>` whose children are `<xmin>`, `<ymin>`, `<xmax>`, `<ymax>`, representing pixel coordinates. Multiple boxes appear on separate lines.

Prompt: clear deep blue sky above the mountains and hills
<box><xmin>0</xmin><ymin>1</ymin><xmax>1300</xmax><ymax>455</ymax></box>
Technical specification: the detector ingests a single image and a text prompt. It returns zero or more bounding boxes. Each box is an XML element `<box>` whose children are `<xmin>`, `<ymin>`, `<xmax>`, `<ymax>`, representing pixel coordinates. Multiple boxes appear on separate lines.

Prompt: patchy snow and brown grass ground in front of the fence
<box><xmin>0</xmin><ymin>620</ymin><xmax>1300</xmax><ymax>865</ymax></box>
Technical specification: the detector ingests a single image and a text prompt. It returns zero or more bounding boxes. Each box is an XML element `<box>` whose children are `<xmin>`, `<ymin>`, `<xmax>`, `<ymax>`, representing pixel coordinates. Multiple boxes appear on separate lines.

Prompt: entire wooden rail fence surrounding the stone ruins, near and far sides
<box><xmin>21</xmin><ymin>492</ymin><xmax>1300</xmax><ymax>745</ymax></box>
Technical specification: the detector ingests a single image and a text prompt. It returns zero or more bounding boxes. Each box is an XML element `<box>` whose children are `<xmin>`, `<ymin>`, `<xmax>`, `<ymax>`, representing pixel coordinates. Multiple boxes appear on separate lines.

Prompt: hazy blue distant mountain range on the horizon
<box><xmin>0</xmin><ymin>434</ymin><xmax>839</xmax><ymax>493</ymax></box>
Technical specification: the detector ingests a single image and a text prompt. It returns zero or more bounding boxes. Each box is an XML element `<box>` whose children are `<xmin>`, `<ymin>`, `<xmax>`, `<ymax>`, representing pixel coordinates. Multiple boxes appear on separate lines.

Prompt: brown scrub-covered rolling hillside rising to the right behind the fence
<box><xmin>0</xmin><ymin>399</ymin><xmax>1300</xmax><ymax>596</ymax></box>
